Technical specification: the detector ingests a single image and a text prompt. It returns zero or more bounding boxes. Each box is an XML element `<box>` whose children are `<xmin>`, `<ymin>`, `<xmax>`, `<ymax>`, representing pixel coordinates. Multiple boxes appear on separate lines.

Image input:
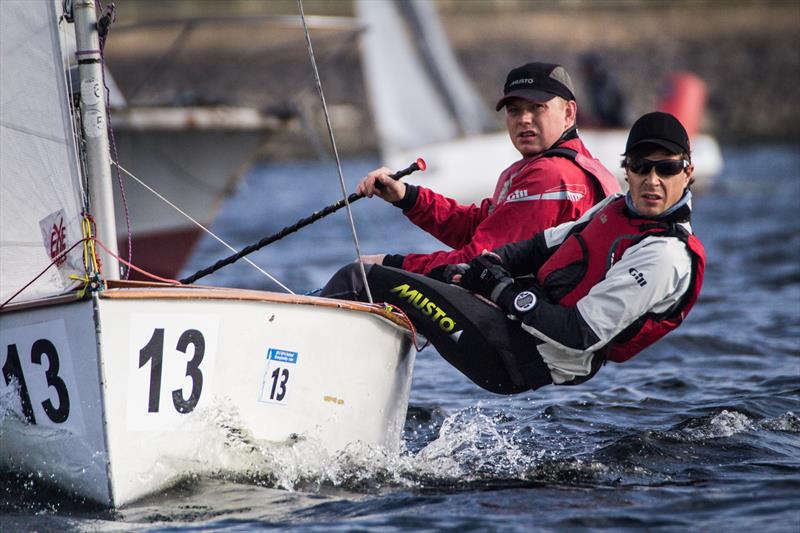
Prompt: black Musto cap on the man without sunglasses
<box><xmin>495</xmin><ymin>63</ymin><xmax>575</xmax><ymax>111</ymax></box>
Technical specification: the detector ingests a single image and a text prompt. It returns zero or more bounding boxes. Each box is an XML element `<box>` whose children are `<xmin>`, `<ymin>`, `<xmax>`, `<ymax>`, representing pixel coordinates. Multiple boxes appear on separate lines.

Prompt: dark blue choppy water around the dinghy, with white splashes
<box><xmin>0</xmin><ymin>146</ymin><xmax>800</xmax><ymax>532</ymax></box>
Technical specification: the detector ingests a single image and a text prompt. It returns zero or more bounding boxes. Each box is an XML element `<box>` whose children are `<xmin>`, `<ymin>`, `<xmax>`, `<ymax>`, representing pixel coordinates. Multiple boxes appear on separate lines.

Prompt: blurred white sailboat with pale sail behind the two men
<box><xmin>355</xmin><ymin>0</ymin><xmax>722</xmax><ymax>203</ymax></box>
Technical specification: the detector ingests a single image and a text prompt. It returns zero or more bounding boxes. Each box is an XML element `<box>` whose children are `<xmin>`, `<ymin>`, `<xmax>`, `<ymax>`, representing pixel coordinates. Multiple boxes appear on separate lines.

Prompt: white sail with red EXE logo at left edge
<box><xmin>0</xmin><ymin>0</ymin><xmax>82</xmax><ymax>303</ymax></box>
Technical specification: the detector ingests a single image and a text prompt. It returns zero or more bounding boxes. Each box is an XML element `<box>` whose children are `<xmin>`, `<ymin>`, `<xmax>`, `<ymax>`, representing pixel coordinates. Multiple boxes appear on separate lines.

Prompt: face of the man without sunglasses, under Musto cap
<box><xmin>506</xmin><ymin>97</ymin><xmax>577</xmax><ymax>157</ymax></box>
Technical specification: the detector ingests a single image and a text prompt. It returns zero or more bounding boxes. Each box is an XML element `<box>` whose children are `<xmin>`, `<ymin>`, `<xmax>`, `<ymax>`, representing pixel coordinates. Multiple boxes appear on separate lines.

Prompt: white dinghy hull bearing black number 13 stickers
<box><xmin>0</xmin><ymin>289</ymin><xmax>414</xmax><ymax>506</ymax></box>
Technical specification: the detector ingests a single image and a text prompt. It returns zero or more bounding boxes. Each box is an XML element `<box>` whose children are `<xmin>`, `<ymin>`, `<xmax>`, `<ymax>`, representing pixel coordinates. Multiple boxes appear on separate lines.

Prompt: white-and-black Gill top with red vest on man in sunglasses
<box><xmin>496</xmin><ymin>193</ymin><xmax>705</xmax><ymax>383</ymax></box>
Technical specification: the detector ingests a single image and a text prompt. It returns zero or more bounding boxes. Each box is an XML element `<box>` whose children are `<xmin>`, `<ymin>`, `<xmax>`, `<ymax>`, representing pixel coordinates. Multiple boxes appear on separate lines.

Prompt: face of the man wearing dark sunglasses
<box><xmin>625</xmin><ymin>149</ymin><xmax>694</xmax><ymax>216</ymax></box>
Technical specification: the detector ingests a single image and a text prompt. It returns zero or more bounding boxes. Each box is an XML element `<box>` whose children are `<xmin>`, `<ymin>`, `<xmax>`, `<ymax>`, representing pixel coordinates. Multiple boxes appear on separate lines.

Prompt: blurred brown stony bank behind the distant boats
<box><xmin>106</xmin><ymin>0</ymin><xmax>800</xmax><ymax>159</ymax></box>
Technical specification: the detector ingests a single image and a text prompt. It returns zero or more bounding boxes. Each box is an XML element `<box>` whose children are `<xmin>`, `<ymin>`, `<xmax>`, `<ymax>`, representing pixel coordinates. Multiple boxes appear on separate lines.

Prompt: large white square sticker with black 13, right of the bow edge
<box><xmin>127</xmin><ymin>314</ymin><xmax>218</xmax><ymax>430</ymax></box>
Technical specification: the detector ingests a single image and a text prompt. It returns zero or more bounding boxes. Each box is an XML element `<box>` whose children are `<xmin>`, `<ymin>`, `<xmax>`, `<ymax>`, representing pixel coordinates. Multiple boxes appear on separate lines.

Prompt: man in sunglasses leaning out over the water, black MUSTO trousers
<box><xmin>323</xmin><ymin>112</ymin><xmax>705</xmax><ymax>394</ymax></box>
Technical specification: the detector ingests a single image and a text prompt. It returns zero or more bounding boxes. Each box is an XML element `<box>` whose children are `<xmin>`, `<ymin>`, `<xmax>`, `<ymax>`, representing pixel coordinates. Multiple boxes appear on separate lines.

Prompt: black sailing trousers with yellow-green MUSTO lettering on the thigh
<box><xmin>319</xmin><ymin>263</ymin><xmax>552</xmax><ymax>394</ymax></box>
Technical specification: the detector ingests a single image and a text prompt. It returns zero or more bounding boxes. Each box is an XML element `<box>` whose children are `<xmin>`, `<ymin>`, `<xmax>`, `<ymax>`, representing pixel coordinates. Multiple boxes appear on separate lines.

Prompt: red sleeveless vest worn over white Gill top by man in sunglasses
<box><xmin>536</xmin><ymin>197</ymin><xmax>705</xmax><ymax>363</ymax></box>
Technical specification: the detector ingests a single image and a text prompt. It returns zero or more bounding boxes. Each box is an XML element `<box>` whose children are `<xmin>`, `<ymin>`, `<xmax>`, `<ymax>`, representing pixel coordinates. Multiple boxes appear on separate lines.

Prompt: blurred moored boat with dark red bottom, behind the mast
<box><xmin>100</xmin><ymin>15</ymin><xmax>366</xmax><ymax>279</ymax></box>
